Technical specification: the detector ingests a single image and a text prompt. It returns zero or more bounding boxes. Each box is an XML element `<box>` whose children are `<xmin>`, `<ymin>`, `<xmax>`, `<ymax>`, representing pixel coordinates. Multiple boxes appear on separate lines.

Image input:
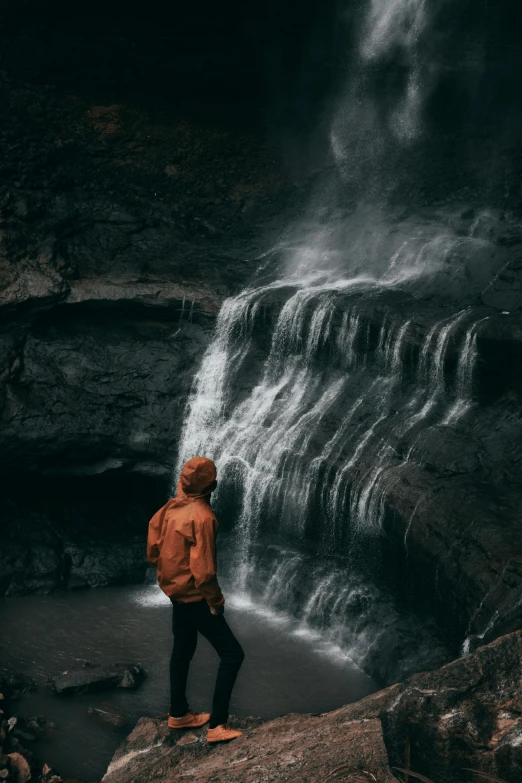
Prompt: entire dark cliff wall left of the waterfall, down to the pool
<box><xmin>0</xmin><ymin>0</ymin><xmax>333</xmax><ymax>593</ymax></box>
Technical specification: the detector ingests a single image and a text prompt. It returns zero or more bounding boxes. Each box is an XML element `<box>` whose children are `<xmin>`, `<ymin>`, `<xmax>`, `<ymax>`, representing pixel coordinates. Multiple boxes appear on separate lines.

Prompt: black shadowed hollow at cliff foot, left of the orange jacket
<box><xmin>0</xmin><ymin>472</ymin><xmax>169</xmax><ymax>595</ymax></box>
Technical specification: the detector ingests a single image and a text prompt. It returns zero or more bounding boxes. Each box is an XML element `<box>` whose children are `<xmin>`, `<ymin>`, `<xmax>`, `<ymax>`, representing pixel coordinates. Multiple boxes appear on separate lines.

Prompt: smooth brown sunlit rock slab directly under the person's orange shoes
<box><xmin>103</xmin><ymin>710</ymin><xmax>395</xmax><ymax>783</ymax></box>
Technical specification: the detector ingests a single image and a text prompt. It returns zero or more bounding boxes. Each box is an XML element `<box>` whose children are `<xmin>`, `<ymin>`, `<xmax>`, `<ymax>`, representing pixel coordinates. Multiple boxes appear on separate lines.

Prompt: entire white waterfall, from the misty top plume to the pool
<box><xmin>173</xmin><ymin>0</ymin><xmax>503</xmax><ymax>681</ymax></box>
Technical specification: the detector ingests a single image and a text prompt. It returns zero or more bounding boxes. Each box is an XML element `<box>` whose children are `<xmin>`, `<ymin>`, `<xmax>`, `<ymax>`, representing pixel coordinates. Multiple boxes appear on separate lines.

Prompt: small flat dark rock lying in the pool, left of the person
<box><xmin>49</xmin><ymin>663</ymin><xmax>146</xmax><ymax>694</ymax></box>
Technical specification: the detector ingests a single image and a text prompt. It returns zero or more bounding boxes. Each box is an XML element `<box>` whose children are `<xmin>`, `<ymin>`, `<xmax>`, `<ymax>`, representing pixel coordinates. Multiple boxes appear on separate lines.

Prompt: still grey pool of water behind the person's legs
<box><xmin>0</xmin><ymin>586</ymin><xmax>377</xmax><ymax>781</ymax></box>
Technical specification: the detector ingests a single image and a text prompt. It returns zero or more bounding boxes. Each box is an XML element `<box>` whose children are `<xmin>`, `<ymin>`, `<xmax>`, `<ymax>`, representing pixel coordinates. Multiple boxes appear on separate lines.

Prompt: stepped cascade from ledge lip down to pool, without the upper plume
<box><xmin>174</xmin><ymin>262</ymin><xmax>478</xmax><ymax>664</ymax></box>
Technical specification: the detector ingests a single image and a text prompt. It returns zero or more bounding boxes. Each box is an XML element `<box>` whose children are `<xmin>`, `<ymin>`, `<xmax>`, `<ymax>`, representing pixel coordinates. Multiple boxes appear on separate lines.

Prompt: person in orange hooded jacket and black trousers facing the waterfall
<box><xmin>147</xmin><ymin>457</ymin><xmax>244</xmax><ymax>742</ymax></box>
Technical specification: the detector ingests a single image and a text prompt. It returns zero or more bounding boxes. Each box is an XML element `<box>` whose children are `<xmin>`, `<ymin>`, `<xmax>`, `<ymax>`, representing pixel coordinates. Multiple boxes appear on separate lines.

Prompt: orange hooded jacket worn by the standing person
<box><xmin>147</xmin><ymin>457</ymin><xmax>225</xmax><ymax>606</ymax></box>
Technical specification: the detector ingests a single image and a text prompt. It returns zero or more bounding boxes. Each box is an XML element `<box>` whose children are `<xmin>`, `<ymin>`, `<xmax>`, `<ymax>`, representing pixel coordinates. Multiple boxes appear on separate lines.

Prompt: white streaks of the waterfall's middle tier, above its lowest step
<box><xmin>175</xmin><ymin>266</ymin><xmax>480</xmax><ymax>588</ymax></box>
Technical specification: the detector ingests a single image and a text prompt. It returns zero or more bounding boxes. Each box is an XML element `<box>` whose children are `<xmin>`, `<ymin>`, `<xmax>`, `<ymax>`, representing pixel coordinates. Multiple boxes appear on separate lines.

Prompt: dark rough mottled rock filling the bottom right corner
<box><xmin>381</xmin><ymin>632</ymin><xmax>522</xmax><ymax>783</ymax></box>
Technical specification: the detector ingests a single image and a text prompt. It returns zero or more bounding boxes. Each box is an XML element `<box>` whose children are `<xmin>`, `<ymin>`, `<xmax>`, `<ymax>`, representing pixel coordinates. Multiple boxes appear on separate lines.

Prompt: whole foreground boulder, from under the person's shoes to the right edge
<box><xmin>103</xmin><ymin>632</ymin><xmax>522</xmax><ymax>783</ymax></box>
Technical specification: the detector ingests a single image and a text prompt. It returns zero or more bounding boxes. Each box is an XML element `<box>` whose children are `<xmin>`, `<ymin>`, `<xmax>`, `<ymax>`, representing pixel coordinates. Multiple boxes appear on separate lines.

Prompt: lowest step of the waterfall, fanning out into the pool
<box><xmin>220</xmin><ymin>538</ymin><xmax>451</xmax><ymax>686</ymax></box>
